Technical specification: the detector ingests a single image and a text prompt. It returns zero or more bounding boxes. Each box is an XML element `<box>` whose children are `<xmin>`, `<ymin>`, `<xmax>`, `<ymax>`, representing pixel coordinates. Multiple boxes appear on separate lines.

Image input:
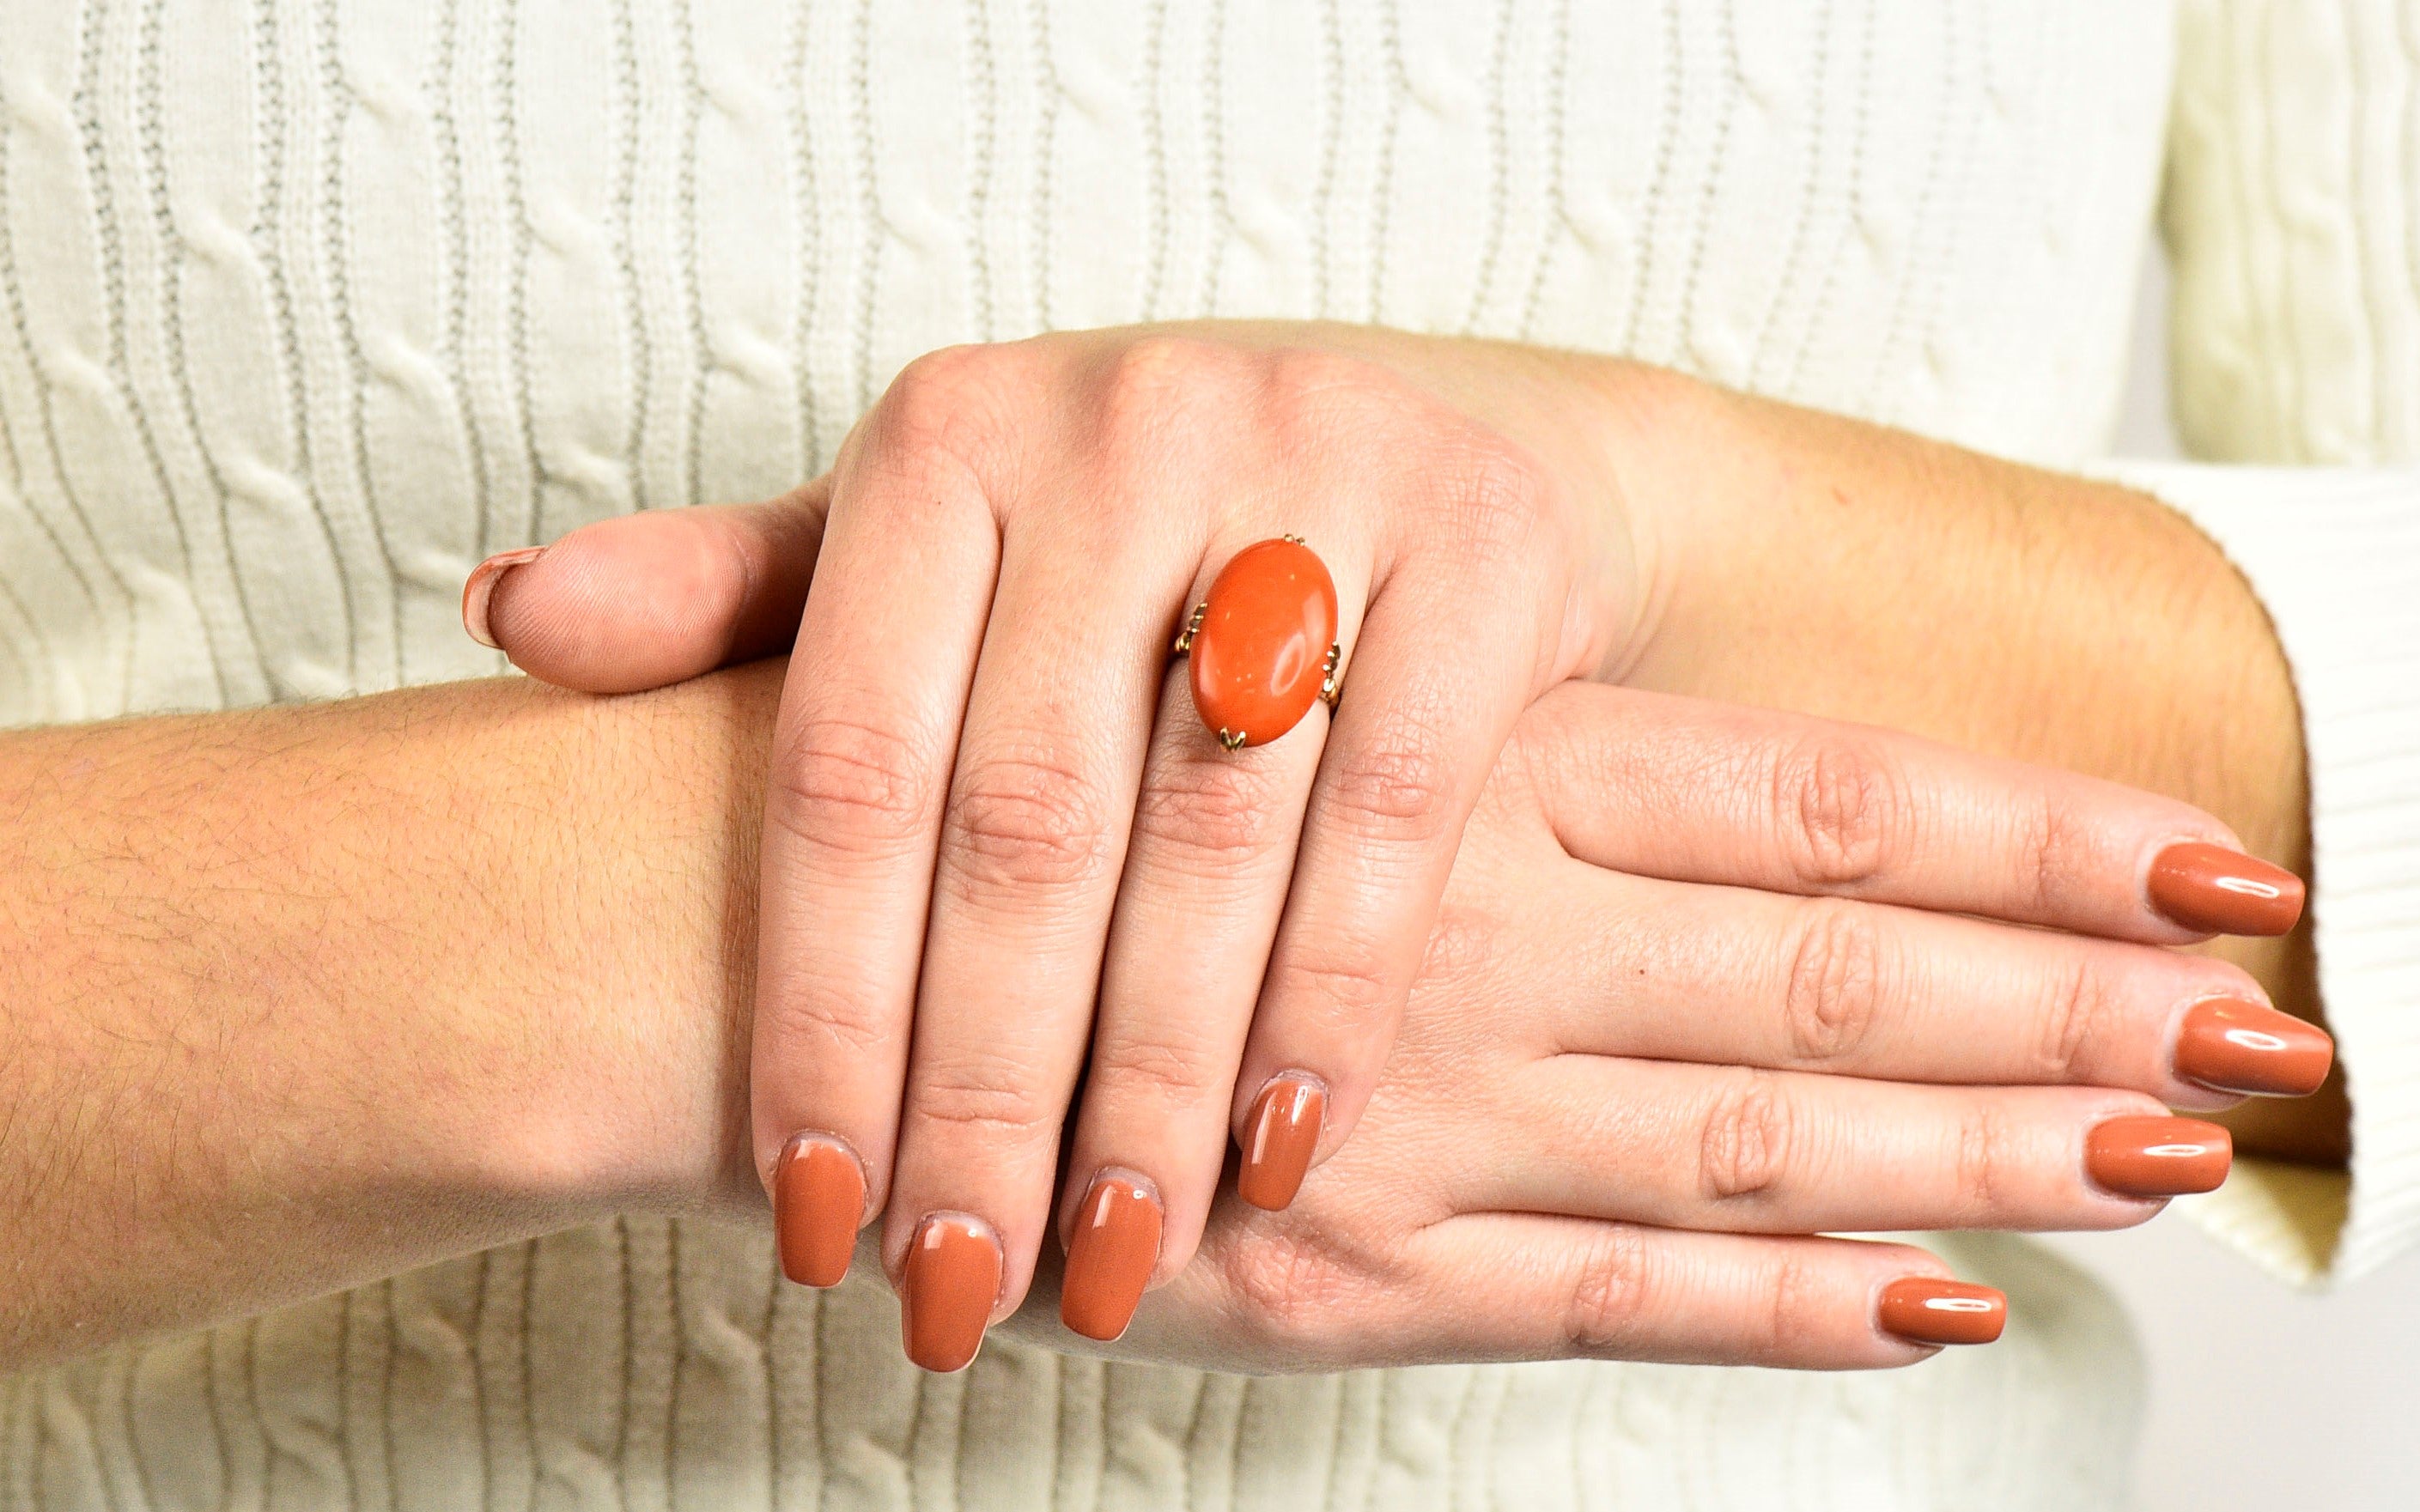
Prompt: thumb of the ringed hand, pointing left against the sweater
<box><xmin>462</xmin><ymin>477</ymin><xmax>832</xmax><ymax>692</ymax></box>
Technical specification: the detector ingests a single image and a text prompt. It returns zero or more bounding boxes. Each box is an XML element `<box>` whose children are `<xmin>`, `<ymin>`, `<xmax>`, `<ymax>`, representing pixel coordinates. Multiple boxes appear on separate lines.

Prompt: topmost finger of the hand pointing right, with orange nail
<box><xmin>1515</xmin><ymin>683</ymin><xmax>2304</xmax><ymax>944</ymax></box>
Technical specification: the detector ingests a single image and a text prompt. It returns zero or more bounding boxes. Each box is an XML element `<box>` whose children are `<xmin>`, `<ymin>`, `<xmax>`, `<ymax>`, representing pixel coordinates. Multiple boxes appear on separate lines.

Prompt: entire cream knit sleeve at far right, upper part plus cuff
<box><xmin>2127</xmin><ymin>0</ymin><xmax>2420</xmax><ymax>1282</ymax></box>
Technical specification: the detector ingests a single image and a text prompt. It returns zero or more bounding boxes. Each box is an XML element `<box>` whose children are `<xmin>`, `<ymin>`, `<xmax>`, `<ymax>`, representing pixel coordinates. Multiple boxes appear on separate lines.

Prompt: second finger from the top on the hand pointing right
<box><xmin>1523</xmin><ymin>864</ymin><xmax>2333</xmax><ymax>1108</ymax></box>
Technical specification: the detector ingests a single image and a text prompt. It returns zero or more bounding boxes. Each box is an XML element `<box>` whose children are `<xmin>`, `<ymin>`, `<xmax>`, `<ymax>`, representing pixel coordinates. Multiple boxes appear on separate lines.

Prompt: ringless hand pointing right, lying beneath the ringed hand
<box><xmin>477</xmin><ymin>551</ymin><xmax>2328</xmax><ymax>1369</ymax></box>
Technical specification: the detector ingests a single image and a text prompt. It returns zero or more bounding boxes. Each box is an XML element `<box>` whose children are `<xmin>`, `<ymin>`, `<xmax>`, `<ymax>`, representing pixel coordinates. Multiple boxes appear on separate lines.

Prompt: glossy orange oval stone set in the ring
<box><xmin>1189</xmin><ymin>539</ymin><xmax>1336</xmax><ymax>750</ymax></box>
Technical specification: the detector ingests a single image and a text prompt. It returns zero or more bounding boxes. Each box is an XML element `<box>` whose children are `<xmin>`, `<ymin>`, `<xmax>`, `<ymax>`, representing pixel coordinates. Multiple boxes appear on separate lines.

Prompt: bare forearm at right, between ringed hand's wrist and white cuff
<box><xmin>1600</xmin><ymin>365</ymin><xmax>2343</xmax><ymax>1159</ymax></box>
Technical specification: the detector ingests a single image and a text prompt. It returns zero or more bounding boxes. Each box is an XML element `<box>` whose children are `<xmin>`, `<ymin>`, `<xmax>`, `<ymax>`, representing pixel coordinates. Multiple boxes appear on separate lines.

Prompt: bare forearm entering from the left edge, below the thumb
<box><xmin>0</xmin><ymin>668</ymin><xmax>777</xmax><ymax>1367</ymax></box>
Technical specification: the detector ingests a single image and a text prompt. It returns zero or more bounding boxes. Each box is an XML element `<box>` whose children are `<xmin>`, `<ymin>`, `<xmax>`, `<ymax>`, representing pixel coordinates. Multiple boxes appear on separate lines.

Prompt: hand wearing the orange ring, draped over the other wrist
<box><xmin>465</xmin><ymin>326</ymin><xmax>1636</xmax><ymax>1367</ymax></box>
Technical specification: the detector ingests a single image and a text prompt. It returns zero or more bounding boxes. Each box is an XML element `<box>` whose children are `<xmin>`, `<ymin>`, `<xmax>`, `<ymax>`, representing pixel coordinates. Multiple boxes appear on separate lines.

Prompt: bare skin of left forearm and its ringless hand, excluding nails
<box><xmin>0</xmin><ymin>663</ymin><xmax>2251</xmax><ymax>1369</ymax></box>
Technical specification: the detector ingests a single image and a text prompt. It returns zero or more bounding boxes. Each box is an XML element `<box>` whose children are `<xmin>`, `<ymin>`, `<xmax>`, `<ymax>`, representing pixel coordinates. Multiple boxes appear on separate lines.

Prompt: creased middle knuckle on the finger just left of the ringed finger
<box><xmin>941</xmin><ymin>755</ymin><xmax>1113</xmax><ymax>890</ymax></box>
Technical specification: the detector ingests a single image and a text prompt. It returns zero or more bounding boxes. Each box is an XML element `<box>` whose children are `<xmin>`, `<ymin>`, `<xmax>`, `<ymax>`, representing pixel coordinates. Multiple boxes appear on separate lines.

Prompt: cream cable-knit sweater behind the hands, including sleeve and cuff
<box><xmin>0</xmin><ymin>0</ymin><xmax>2420</xmax><ymax>1512</ymax></box>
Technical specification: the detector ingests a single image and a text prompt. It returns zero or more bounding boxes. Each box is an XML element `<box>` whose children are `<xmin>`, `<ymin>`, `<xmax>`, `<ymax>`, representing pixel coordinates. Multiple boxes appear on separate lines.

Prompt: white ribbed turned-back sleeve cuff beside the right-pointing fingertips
<box><xmin>2115</xmin><ymin>465</ymin><xmax>2420</xmax><ymax>1284</ymax></box>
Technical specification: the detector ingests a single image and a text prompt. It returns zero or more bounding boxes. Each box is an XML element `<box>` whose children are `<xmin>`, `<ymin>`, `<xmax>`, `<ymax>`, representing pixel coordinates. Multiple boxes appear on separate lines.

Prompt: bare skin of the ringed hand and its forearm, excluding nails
<box><xmin>494</xmin><ymin>322</ymin><xmax>2347</xmax><ymax>1238</ymax></box>
